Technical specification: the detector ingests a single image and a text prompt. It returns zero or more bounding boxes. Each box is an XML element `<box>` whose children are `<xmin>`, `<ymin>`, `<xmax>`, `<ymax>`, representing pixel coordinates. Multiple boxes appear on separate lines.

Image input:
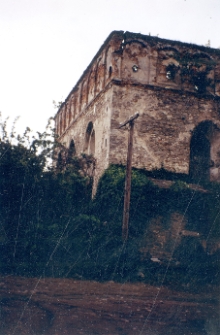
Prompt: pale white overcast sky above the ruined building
<box><xmin>0</xmin><ymin>0</ymin><xmax>220</xmax><ymax>135</ymax></box>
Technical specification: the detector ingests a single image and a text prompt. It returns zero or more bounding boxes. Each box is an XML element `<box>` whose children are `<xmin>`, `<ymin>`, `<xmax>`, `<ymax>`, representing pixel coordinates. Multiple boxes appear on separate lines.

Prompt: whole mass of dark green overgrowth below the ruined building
<box><xmin>0</xmin><ymin>119</ymin><xmax>220</xmax><ymax>292</ymax></box>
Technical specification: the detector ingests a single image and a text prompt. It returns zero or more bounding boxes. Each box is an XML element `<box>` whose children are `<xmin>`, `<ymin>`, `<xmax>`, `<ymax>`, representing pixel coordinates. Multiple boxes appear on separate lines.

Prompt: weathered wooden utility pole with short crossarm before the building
<box><xmin>119</xmin><ymin>113</ymin><xmax>139</xmax><ymax>241</ymax></box>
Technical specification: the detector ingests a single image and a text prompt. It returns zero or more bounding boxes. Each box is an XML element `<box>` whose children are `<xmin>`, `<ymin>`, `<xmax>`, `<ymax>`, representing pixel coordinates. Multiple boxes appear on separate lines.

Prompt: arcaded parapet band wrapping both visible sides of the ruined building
<box><xmin>55</xmin><ymin>31</ymin><xmax>220</xmax><ymax>143</ymax></box>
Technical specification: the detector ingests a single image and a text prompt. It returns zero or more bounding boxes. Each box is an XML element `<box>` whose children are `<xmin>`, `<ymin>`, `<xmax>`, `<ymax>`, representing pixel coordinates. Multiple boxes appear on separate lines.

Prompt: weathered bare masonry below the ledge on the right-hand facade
<box><xmin>110</xmin><ymin>85</ymin><xmax>220</xmax><ymax>177</ymax></box>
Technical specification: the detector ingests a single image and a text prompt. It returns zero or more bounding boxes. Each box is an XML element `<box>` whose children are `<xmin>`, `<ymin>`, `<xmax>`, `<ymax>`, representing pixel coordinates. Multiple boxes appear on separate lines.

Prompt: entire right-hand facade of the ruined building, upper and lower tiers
<box><xmin>110</xmin><ymin>33</ymin><xmax>220</xmax><ymax>180</ymax></box>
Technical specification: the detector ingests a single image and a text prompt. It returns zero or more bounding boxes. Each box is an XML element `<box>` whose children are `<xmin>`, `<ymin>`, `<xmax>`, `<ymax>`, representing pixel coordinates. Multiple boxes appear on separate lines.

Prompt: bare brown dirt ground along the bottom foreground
<box><xmin>0</xmin><ymin>277</ymin><xmax>220</xmax><ymax>335</ymax></box>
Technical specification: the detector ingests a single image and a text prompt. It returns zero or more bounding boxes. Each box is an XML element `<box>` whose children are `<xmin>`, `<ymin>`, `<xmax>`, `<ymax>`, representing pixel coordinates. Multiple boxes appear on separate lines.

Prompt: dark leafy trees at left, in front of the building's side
<box><xmin>0</xmin><ymin>115</ymin><xmax>91</xmax><ymax>275</ymax></box>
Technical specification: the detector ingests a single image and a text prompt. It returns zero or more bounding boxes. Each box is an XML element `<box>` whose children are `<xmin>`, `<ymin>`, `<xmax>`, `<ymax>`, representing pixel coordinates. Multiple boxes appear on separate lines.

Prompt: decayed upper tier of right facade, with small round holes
<box><xmin>121</xmin><ymin>33</ymin><xmax>220</xmax><ymax>96</ymax></box>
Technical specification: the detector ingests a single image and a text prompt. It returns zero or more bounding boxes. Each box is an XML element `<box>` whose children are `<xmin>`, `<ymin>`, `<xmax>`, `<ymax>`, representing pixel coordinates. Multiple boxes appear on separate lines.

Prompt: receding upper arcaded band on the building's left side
<box><xmin>55</xmin><ymin>32</ymin><xmax>123</xmax><ymax>142</ymax></box>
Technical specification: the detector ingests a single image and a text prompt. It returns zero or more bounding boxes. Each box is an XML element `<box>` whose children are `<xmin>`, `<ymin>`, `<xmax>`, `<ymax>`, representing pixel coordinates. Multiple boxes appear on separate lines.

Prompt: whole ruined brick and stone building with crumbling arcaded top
<box><xmin>55</xmin><ymin>31</ymin><xmax>220</xmax><ymax>192</ymax></box>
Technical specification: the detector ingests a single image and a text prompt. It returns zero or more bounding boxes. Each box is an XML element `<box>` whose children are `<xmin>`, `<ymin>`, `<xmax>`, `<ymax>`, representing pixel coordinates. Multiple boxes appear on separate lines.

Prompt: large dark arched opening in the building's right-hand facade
<box><xmin>189</xmin><ymin>121</ymin><xmax>214</xmax><ymax>183</ymax></box>
